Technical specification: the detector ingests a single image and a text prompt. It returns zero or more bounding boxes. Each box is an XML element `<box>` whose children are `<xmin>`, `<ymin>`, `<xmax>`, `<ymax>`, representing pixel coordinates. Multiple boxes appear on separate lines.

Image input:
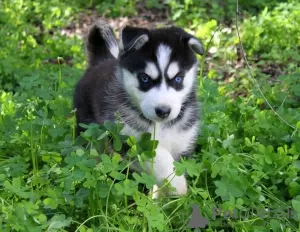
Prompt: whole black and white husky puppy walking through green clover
<box><xmin>74</xmin><ymin>21</ymin><xmax>203</xmax><ymax>195</ymax></box>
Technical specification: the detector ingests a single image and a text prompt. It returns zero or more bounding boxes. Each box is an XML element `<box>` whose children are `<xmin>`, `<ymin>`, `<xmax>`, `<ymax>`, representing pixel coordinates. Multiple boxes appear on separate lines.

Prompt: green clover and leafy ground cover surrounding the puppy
<box><xmin>0</xmin><ymin>0</ymin><xmax>300</xmax><ymax>232</ymax></box>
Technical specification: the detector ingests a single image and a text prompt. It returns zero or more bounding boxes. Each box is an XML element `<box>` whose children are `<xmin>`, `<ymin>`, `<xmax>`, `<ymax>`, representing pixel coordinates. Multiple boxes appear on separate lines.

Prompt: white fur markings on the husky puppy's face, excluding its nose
<box><xmin>122</xmin><ymin>56</ymin><xmax>197</xmax><ymax>122</ymax></box>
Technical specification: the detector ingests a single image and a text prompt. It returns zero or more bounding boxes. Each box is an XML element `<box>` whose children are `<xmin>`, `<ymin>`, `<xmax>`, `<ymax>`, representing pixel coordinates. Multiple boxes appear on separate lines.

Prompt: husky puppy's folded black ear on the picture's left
<box><xmin>120</xmin><ymin>26</ymin><xmax>149</xmax><ymax>52</ymax></box>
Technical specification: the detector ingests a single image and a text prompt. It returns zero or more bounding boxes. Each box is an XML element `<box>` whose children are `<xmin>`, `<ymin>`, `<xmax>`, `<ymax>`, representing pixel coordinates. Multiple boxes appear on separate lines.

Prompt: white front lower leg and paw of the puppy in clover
<box><xmin>148</xmin><ymin>145</ymin><xmax>187</xmax><ymax>195</ymax></box>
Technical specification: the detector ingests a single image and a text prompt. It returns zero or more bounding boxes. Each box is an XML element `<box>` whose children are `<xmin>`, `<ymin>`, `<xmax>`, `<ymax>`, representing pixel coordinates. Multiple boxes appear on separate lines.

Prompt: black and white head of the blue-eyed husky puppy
<box><xmin>119</xmin><ymin>27</ymin><xmax>204</xmax><ymax>122</ymax></box>
